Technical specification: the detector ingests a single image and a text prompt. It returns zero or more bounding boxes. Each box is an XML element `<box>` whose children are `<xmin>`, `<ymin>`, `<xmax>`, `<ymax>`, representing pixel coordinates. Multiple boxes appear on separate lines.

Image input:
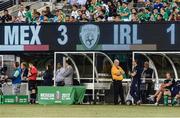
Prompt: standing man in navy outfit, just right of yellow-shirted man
<box><xmin>130</xmin><ymin>61</ymin><xmax>142</xmax><ymax>105</ymax></box>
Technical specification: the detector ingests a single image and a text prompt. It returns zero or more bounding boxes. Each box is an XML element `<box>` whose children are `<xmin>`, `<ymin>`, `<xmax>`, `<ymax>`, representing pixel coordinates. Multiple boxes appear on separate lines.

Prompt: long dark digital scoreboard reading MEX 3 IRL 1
<box><xmin>0</xmin><ymin>22</ymin><xmax>180</xmax><ymax>51</ymax></box>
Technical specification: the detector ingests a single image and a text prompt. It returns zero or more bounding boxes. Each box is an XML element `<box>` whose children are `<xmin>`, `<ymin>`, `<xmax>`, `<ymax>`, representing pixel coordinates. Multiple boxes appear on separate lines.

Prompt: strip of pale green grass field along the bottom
<box><xmin>0</xmin><ymin>105</ymin><xmax>180</xmax><ymax>118</ymax></box>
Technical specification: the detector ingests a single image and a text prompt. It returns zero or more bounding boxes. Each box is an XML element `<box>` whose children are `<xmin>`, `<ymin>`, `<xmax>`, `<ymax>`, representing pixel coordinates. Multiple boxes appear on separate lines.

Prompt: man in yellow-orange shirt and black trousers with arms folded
<box><xmin>111</xmin><ymin>59</ymin><xmax>125</xmax><ymax>105</ymax></box>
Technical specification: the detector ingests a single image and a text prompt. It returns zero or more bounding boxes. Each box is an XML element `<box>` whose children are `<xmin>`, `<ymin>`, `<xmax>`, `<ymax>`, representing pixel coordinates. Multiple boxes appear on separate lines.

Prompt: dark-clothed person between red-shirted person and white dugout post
<box><xmin>43</xmin><ymin>65</ymin><xmax>53</xmax><ymax>86</ymax></box>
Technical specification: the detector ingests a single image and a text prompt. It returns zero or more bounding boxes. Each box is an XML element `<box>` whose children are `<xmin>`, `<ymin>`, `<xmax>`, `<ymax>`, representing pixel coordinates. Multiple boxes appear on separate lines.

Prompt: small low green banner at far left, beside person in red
<box><xmin>2</xmin><ymin>95</ymin><xmax>28</xmax><ymax>104</ymax></box>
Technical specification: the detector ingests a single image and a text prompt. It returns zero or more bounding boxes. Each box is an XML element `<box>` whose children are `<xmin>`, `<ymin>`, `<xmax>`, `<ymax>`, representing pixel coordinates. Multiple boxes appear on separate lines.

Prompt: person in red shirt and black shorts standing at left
<box><xmin>28</xmin><ymin>63</ymin><xmax>38</xmax><ymax>104</ymax></box>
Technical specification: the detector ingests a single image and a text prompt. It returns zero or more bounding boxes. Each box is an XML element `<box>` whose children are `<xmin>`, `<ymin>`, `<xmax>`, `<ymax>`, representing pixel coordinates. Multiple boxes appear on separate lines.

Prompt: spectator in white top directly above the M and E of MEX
<box><xmin>18</xmin><ymin>5</ymin><xmax>26</xmax><ymax>22</ymax></box>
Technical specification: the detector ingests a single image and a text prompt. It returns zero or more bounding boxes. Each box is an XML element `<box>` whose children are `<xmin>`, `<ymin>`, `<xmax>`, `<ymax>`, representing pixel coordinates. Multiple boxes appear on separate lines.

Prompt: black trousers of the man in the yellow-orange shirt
<box><xmin>113</xmin><ymin>80</ymin><xmax>125</xmax><ymax>104</ymax></box>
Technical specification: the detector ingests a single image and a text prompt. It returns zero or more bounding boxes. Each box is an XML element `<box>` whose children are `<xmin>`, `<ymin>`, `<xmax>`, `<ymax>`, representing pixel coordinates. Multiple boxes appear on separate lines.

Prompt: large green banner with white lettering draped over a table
<box><xmin>38</xmin><ymin>86</ymin><xmax>85</xmax><ymax>104</ymax></box>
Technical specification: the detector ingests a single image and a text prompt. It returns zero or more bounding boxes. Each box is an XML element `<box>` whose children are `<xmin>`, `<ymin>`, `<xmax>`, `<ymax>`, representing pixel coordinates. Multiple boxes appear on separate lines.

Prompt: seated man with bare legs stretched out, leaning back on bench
<box><xmin>148</xmin><ymin>72</ymin><xmax>174</xmax><ymax>105</ymax></box>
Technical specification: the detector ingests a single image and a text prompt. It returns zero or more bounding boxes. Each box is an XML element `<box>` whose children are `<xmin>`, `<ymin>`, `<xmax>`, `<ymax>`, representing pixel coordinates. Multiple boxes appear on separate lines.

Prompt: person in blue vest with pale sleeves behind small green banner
<box><xmin>10</xmin><ymin>62</ymin><xmax>22</xmax><ymax>95</ymax></box>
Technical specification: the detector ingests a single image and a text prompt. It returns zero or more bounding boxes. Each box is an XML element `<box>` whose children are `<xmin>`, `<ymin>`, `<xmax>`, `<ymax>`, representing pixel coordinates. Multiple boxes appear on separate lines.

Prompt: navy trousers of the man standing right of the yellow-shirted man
<box><xmin>130</xmin><ymin>78</ymin><xmax>141</xmax><ymax>103</ymax></box>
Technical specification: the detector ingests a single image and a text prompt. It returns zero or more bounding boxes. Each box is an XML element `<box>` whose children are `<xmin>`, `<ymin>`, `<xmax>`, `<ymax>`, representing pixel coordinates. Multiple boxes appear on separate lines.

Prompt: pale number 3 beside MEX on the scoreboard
<box><xmin>57</xmin><ymin>25</ymin><xmax>68</xmax><ymax>45</ymax></box>
